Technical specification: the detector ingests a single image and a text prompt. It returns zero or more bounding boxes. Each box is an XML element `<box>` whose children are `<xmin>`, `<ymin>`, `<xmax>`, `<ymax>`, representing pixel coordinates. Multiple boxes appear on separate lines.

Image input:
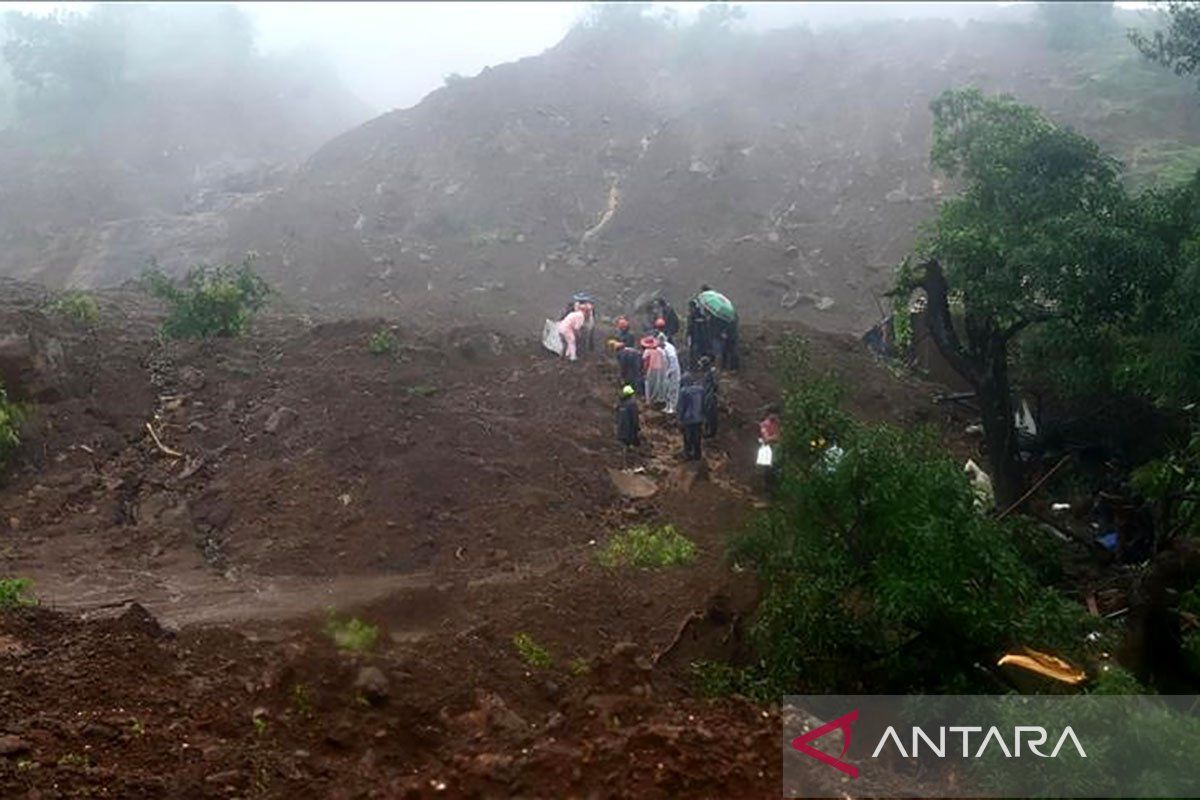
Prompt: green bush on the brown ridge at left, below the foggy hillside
<box><xmin>143</xmin><ymin>257</ymin><xmax>270</xmax><ymax>338</ymax></box>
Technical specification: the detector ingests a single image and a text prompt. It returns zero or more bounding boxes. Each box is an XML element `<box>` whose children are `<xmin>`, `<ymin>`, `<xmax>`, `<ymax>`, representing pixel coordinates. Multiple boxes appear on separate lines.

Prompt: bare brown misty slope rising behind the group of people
<box><xmin>206</xmin><ymin>11</ymin><xmax>1200</xmax><ymax>330</ymax></box>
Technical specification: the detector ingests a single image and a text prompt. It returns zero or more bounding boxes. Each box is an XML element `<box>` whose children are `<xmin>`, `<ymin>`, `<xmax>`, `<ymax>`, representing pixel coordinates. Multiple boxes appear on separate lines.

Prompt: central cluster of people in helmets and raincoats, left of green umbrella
<box><xmin>613</xmin><ymin>297</ymin><xmax>718</xmax><ymax>461</ymax></box>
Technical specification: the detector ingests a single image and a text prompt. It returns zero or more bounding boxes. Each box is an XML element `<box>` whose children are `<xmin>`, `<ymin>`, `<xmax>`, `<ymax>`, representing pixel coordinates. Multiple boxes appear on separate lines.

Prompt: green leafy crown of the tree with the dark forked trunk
<box><xmin>920</xmin><ymin>89</ymin><xmax>1163</xmax><ymax>331</ymax></box>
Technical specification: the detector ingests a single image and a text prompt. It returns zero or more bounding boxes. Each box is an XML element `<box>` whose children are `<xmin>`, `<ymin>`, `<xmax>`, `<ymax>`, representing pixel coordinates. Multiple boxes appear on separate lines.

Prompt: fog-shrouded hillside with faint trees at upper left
<box><xmin>0</xmin><ymin>4</ymin><xmax>370</xmax><ymax>291</ymax></box>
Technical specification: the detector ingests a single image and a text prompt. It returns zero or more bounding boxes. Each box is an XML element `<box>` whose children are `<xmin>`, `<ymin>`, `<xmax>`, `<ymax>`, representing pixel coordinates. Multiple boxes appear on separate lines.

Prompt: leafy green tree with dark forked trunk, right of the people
<box><xmin>893</xmin><ymin>89</ymin><xmax>1163</xmax><ymax>505</ymax></box>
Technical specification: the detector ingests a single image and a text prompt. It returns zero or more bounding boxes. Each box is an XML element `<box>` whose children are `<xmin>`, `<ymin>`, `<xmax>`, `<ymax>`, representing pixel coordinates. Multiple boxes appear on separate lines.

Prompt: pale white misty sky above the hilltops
<box><xmin>0</xmin><ymin>1</ymin><xmax>1146</xmax><ymax>112</ymax></box>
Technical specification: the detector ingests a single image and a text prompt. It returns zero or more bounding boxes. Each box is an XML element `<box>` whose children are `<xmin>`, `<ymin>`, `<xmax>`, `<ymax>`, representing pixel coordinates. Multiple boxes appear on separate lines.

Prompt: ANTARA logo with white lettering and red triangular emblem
<box><xmin>792</xmin><ymin>709</ymin><xmax>1087</xmax><ymax>778</ymax></box>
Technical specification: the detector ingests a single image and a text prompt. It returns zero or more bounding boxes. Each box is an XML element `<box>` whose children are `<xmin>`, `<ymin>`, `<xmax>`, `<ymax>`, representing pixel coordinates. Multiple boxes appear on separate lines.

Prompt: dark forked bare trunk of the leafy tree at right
<box><xmin>918</xmin><ymin>260</ymin><xmax>1024</xmax><ymax>509</ymax></box>
